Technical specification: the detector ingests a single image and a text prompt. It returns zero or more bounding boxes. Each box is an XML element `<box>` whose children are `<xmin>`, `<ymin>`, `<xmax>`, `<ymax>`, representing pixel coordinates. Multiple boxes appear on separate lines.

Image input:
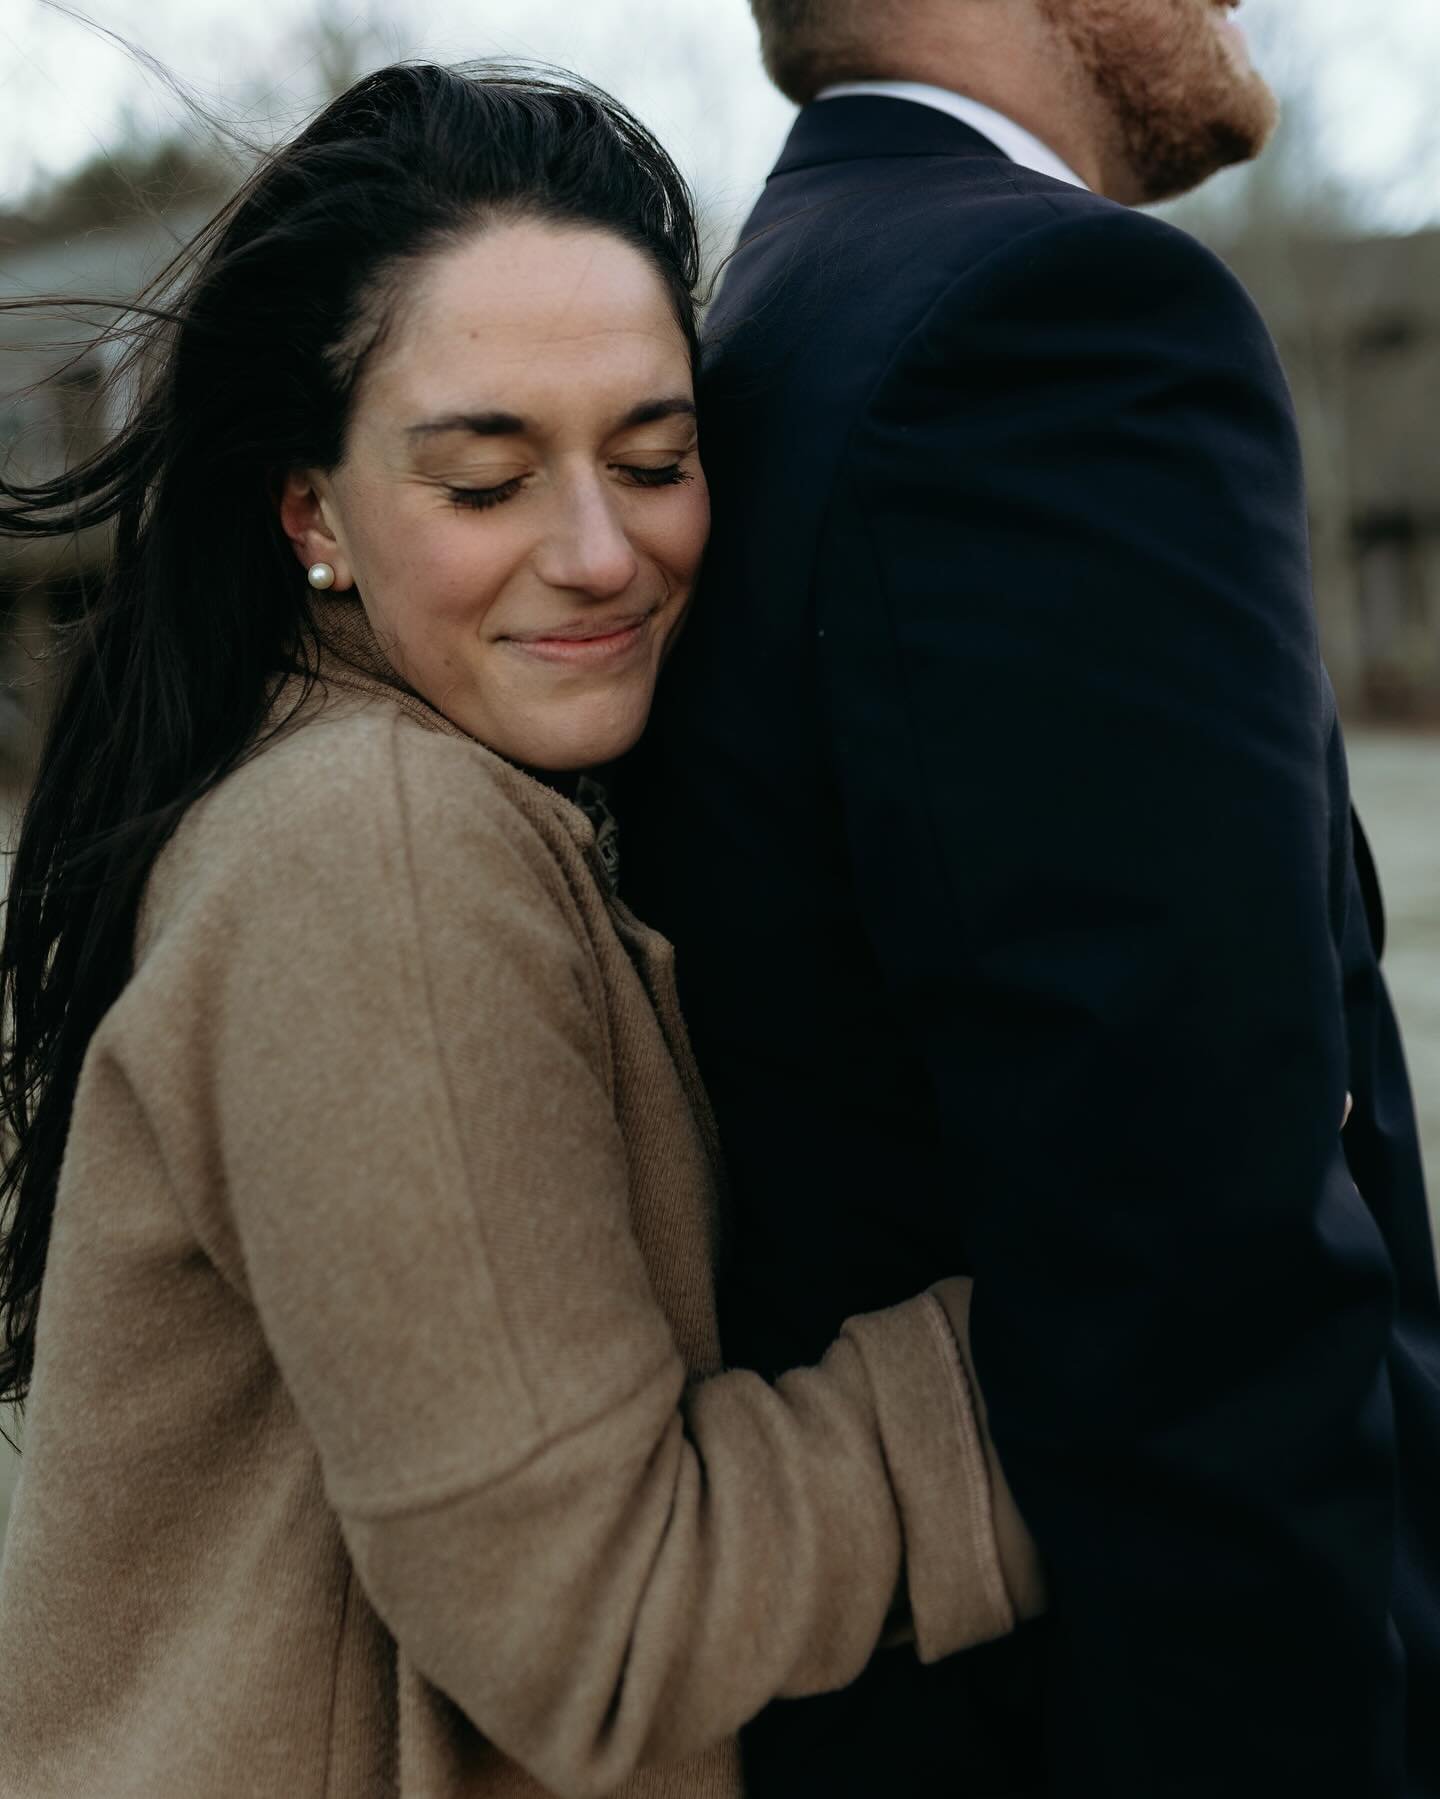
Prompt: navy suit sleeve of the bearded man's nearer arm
<box><xmin>817</xmin><ymin>212</ymin><xmax>1402</xmax><ymax>1799</ymax></box>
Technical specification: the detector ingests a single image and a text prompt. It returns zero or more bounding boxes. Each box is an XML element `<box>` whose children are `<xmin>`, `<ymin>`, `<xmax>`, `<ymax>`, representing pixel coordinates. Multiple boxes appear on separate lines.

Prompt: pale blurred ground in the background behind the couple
<box><xmin>0</xmin><ymin>734</ymin><xmax>1440</xmax><ymax>1536</ymax></box>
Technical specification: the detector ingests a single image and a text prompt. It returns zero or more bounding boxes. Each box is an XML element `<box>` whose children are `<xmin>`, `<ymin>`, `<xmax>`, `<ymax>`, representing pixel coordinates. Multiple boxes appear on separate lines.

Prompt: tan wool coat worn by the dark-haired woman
<box><xmin>0</xmin><ymin>599</ymin><xmax>1037</xmax><ymax>1799</ymax></box>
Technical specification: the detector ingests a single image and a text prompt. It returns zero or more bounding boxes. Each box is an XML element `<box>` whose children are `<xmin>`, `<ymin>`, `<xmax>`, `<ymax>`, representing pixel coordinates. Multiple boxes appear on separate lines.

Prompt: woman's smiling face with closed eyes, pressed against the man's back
<box><xmin>283</xmin><ymin>223</ymin><xmax>709</xmax><ymax>770</ymax></box>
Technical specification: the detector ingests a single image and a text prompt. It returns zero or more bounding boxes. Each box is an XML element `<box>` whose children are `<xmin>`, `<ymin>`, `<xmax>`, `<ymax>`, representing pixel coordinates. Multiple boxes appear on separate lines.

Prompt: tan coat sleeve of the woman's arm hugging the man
<box><xmin>162</xmin><ymin>727</ymin><xmax>1033</xmax><ymax>1795</ymax></box>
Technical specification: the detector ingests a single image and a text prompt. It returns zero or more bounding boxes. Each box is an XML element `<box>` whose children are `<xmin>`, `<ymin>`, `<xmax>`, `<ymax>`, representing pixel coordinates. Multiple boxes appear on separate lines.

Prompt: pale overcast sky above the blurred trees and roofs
<box><xmin>0</xmin><ymin>0</ymin><xmax>1440</xmax><ymax>228</ymax></box>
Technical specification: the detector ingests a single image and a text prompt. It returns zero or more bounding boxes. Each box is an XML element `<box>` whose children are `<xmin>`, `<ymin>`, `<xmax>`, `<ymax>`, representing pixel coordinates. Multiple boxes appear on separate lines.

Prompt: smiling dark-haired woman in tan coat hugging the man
<box><xmin>0</xmin><ymin>68</ymin><xmax>1039</xmax><ymax>1799</ymax></box>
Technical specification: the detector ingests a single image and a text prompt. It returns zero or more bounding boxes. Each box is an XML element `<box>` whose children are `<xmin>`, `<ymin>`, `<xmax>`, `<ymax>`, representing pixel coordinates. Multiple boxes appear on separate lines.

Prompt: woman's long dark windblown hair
<box><xmin>0</xmin><ymin>65</ymin><xmax>698</xmax><ymax>1400</ymax></box>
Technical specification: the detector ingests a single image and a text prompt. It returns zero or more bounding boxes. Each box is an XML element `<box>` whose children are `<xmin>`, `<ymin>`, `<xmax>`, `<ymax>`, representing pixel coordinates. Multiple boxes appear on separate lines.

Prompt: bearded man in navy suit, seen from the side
<box><xmin>626</xmin><ymin>0</ymin><xmax>1440</xmax><ymax>1799</ymax></box>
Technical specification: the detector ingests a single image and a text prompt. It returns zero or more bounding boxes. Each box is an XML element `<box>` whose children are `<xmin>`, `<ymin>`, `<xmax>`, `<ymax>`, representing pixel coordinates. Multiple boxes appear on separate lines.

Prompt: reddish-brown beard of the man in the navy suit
<box><xmin>1044</xmin><ymin>0</ymin><xmax>1278</xmax><ymax>201</ymax></box>
